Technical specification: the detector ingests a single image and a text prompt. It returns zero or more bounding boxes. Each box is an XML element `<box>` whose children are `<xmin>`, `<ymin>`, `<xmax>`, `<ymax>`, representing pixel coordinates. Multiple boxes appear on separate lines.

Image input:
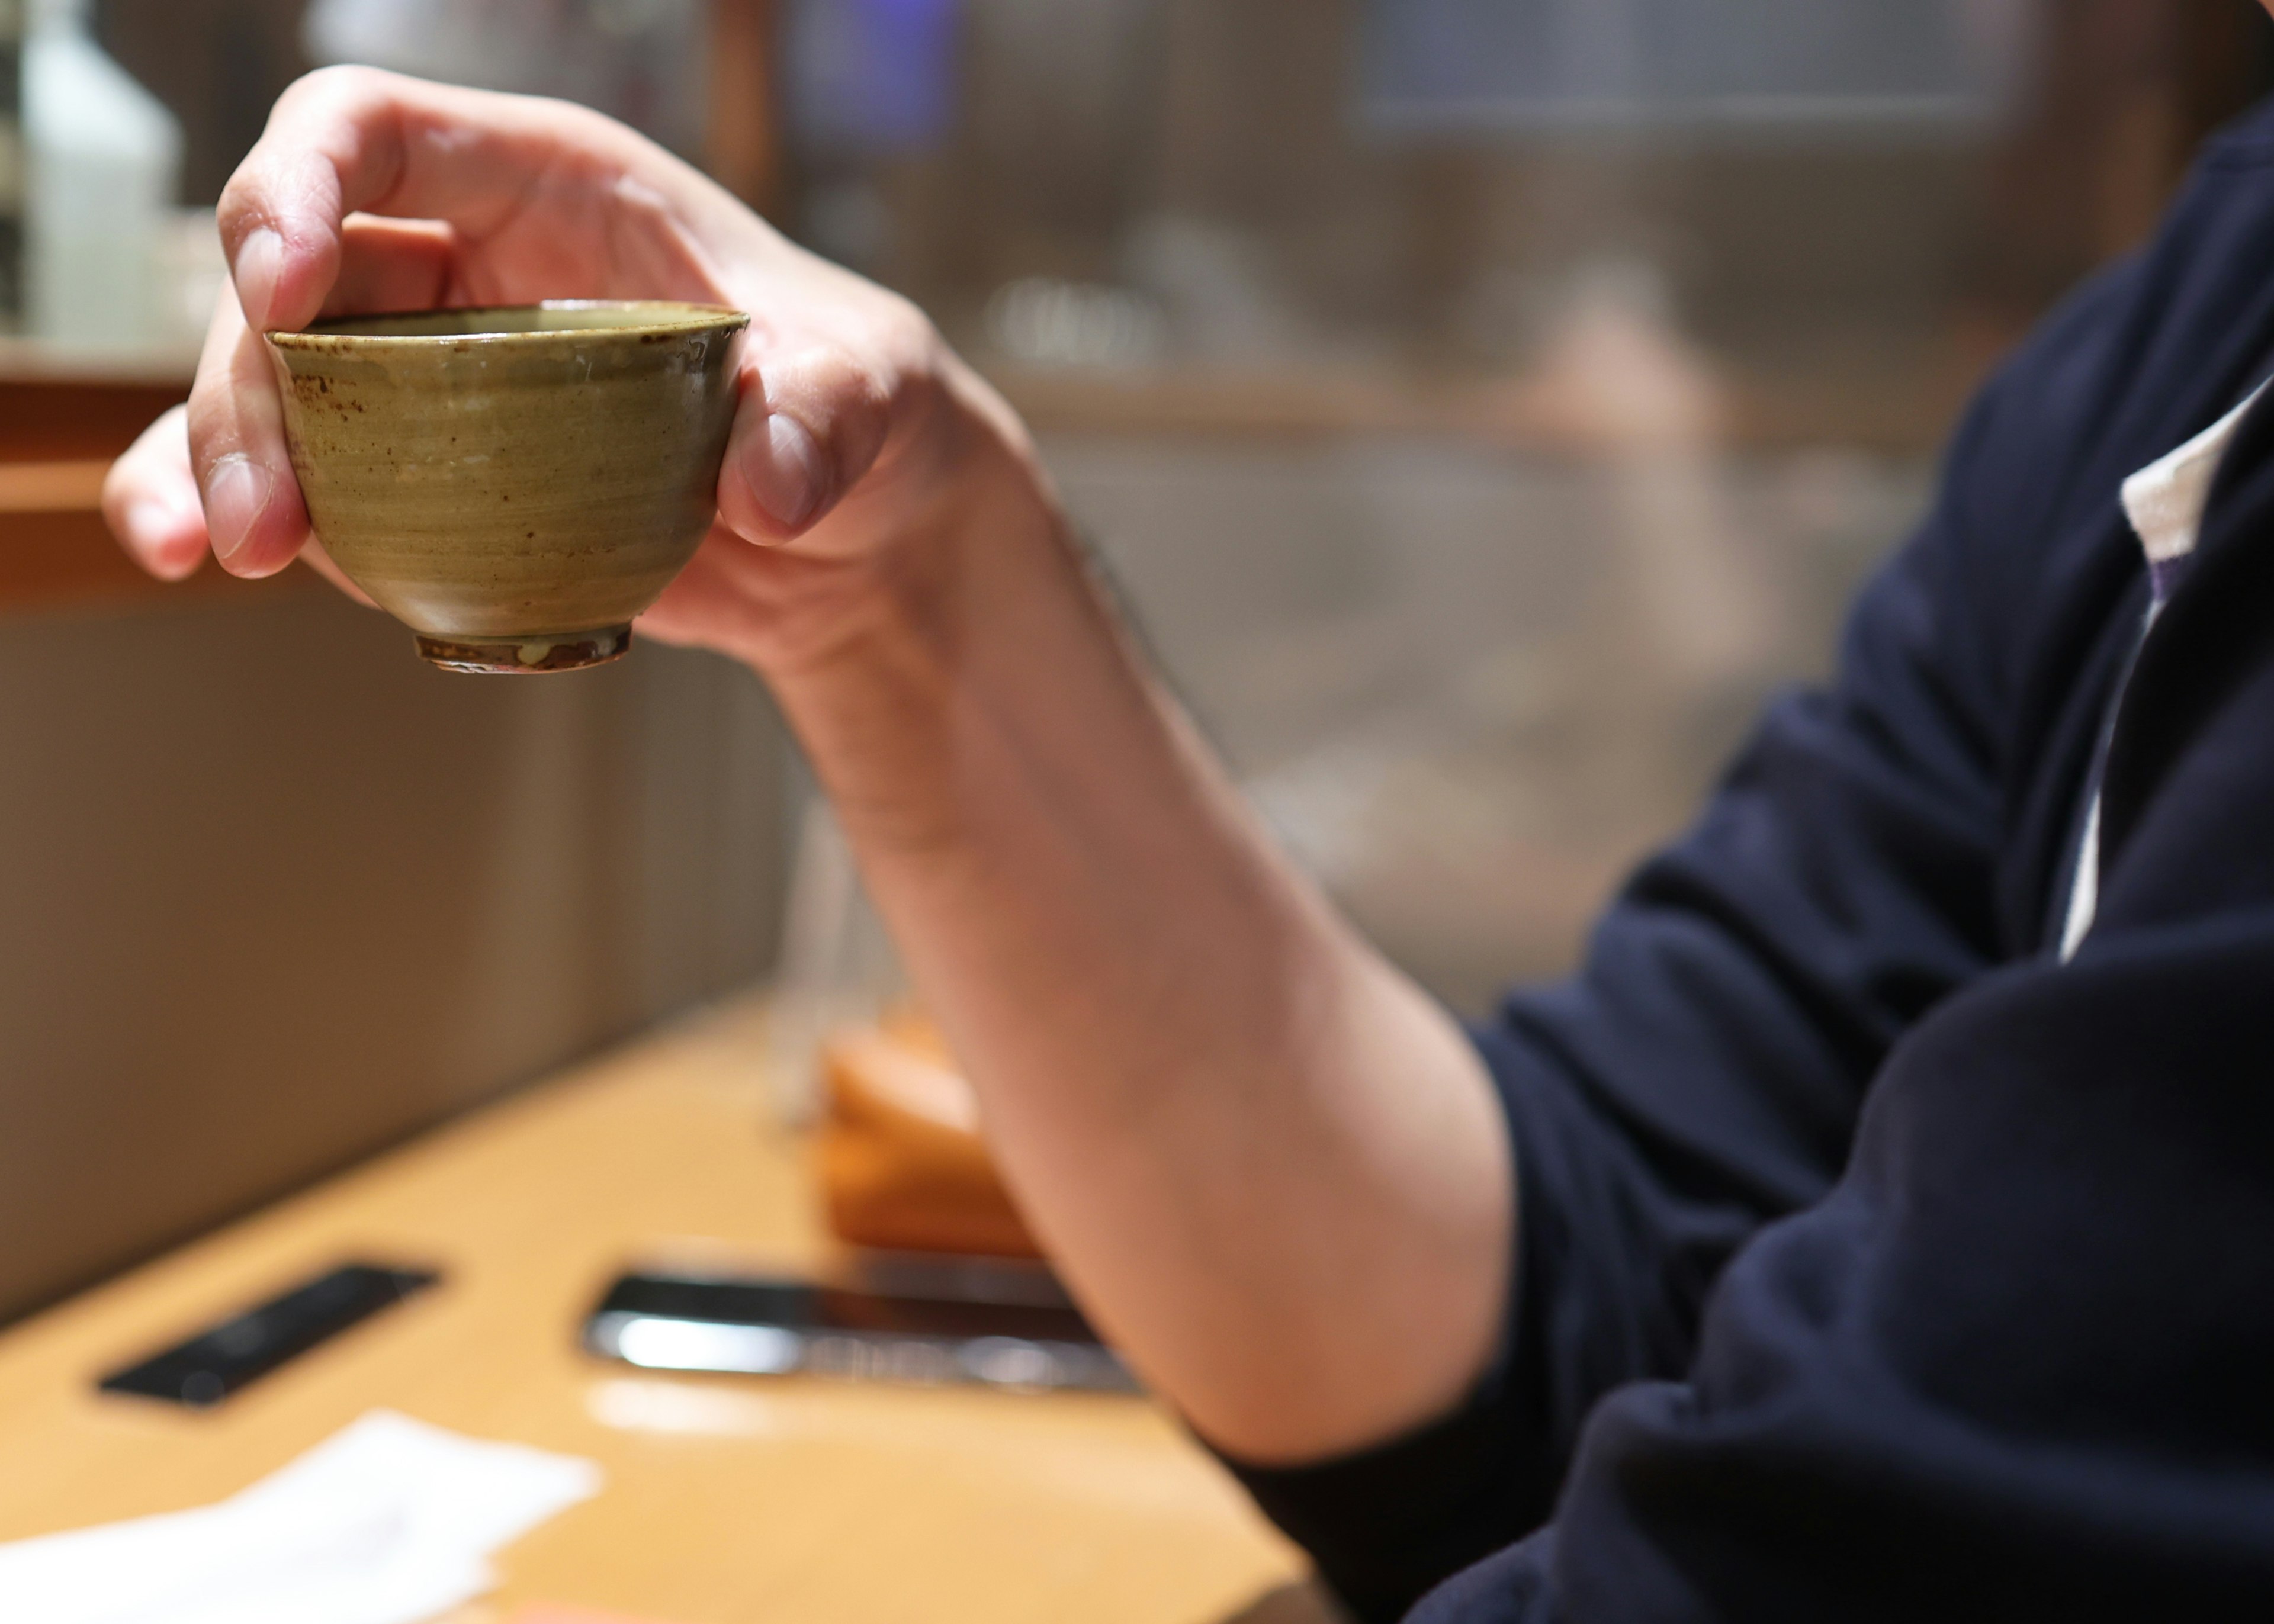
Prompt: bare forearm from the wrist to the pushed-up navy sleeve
<box><xmin>769</xmin><ymin>387</ymin><xmax>1512</xmax><ymax>1460</ymax></box>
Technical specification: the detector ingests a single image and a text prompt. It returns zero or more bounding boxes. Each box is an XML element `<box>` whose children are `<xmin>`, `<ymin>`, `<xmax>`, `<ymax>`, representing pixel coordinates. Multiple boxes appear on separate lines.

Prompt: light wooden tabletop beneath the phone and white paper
<box><xmin>0</xmin><ymin>1008</ymin><xmax>1324</xmax><ymax>1624</ymax></box>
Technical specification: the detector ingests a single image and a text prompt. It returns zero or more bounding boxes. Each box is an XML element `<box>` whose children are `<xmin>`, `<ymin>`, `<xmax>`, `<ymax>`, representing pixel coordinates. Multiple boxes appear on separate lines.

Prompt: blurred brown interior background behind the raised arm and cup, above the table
<box><xmin>0</xmin><ymin>0</ymin><xmax>2274</xmax><ymax>1317</ymax></box>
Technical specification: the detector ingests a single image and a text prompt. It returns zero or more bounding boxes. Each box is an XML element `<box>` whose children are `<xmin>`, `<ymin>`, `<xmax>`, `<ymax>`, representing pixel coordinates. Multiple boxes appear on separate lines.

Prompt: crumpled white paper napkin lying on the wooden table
<box><xmin>0</xmin><ymin>1410</ymin><xmax>600</xmax><ymax>1624</ymax></box>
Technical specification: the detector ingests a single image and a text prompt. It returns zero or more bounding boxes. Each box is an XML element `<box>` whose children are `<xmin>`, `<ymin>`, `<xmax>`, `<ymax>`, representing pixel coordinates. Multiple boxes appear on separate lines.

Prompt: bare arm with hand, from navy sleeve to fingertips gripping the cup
<box><xmin>109</xmin><ymin>73</ymin><xmax>1512</xmax><ymax>1460</ymax></box>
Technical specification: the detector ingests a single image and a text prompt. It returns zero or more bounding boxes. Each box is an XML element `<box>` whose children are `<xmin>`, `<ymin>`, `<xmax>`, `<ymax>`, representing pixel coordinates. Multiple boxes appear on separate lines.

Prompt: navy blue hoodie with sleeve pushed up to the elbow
<box><xmin>1242</xmin><ymin>95</ymin><xmax>2274</xmax><ymax>1624</ymax></box>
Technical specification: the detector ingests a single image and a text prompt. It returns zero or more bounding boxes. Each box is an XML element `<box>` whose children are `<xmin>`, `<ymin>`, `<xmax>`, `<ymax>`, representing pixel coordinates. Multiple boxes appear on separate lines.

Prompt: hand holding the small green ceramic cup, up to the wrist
<box><xmin>102</xmin><ymin>68</ymin><xmax>1046</xmax><ymax>667</ymax></box>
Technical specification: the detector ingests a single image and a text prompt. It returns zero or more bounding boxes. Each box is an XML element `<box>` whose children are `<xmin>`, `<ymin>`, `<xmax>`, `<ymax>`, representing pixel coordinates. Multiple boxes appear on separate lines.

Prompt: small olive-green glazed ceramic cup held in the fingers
<box><xmin>268</xmin><ymin>300</ymin><xmax>748</xmax><ymax>671</ymax></box>
